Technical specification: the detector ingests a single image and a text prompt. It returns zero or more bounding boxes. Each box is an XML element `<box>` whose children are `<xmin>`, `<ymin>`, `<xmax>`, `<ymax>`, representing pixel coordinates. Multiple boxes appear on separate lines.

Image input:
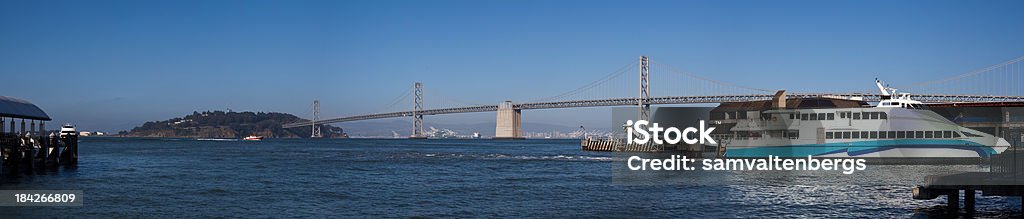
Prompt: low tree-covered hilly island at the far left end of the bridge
<box><xmin>119</xmin><ymin>111</ymin><xmax>346</xmax><ymax>138</ymax></box>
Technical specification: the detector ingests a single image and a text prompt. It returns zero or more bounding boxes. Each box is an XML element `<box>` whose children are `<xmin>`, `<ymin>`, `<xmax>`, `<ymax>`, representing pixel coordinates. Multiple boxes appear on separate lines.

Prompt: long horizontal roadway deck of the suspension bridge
<box><xmin>283</xmin><ymin>94</ymin><xmax>1024</xmax><ymax>128</ymax></box>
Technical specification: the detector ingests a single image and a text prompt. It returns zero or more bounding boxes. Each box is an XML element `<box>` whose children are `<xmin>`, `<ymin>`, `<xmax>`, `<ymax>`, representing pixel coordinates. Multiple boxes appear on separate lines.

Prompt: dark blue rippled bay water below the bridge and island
<box><xmin>0</xmin><ymin>138</ymin><xmax>1020</xmax><ymax>218</ymax></box>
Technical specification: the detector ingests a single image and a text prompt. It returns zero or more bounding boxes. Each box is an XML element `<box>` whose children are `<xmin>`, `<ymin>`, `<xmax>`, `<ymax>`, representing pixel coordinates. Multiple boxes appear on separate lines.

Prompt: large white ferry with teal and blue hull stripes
<box><xmin>713</xmin><ymin>80</ymin><xmax>1010</xmax><ymax>158</ymax></box>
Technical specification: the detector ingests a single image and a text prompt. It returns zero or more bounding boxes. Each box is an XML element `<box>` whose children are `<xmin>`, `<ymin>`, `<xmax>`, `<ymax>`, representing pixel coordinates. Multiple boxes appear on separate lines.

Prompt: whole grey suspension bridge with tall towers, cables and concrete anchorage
<box><xmin>284</xmin><ymin>56</ymin><xmax>1024</xmax><ymax>138</ymax></box>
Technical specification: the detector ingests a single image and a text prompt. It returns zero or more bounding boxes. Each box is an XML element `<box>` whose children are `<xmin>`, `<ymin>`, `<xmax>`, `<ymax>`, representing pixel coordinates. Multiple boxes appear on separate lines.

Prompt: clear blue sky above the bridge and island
<box><xmin>0</xmin><ymin>0</ymin><xmax>1024</xmax><ymax>131</ymax></box>
